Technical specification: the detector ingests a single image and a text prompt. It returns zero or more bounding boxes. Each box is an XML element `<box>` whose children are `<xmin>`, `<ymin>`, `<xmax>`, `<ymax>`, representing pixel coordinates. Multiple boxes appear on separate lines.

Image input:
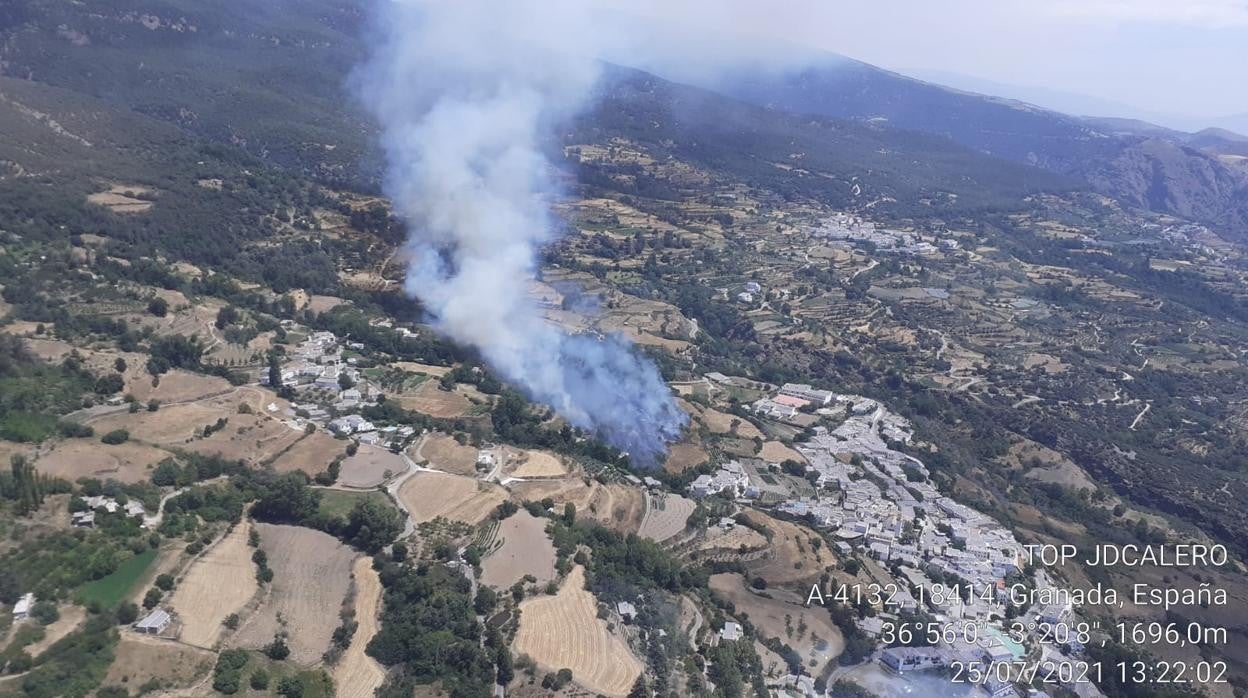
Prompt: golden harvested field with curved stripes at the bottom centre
<box><xmin>512</xmin><ymin>566</ymin><xmax>641</xmax><ymax>696</ymax></box>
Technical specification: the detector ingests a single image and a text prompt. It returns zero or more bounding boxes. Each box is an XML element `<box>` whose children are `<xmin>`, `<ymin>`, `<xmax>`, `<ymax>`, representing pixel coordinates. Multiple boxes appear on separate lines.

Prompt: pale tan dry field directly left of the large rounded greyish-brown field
<box><xmin>168</xmin><ymin>521</ymin><xmax>256</xmax><ymax>648</ymax></box>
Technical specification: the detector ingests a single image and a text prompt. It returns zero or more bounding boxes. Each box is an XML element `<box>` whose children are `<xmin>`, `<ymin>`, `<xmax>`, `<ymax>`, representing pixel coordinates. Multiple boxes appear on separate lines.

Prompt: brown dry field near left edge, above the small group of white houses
<box><xmin>31</xmin><ymin>438</ymin><xmax>171</xmax><ymax>483</ymax></box>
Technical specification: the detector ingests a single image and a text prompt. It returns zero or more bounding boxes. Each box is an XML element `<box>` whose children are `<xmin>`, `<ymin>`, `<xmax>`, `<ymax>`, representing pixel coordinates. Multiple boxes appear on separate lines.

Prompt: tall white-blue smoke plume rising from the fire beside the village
<box><xmin>357</xmin><ymin>0</ymin><xmax>703</xmax><ymax>465</ymax></box>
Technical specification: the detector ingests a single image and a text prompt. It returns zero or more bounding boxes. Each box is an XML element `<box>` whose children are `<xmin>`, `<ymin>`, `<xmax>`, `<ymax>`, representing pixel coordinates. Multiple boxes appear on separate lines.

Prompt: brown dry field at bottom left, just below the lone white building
<box><xmin>104</xmin><ymin>632</ymin><xmax>216</xmax><ymax>688</ymax></box>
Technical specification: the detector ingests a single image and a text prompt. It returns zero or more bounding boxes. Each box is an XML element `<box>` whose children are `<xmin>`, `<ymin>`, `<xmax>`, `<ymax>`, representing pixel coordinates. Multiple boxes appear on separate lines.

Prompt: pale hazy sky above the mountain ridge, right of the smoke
<box><xmin>628</xmin><ymin>0</ymin><xmax>1248</xmax><ymax>128</ymax></box>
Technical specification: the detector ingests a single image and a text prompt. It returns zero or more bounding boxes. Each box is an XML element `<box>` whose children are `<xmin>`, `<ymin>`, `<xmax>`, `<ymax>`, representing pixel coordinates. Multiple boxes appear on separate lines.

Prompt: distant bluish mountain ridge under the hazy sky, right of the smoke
<box><xmin>716</xmin><ymin>56</ymin><xmax>1248</xmax><ymax>238</ymax></box>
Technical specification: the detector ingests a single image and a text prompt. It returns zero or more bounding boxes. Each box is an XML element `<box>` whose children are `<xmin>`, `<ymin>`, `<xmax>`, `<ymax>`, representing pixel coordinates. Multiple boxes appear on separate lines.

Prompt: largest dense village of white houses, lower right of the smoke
<box><xmin>689</xmin><ymin>385</ymin><xmax>1094</xmax><ymax>698</ymax></box>
